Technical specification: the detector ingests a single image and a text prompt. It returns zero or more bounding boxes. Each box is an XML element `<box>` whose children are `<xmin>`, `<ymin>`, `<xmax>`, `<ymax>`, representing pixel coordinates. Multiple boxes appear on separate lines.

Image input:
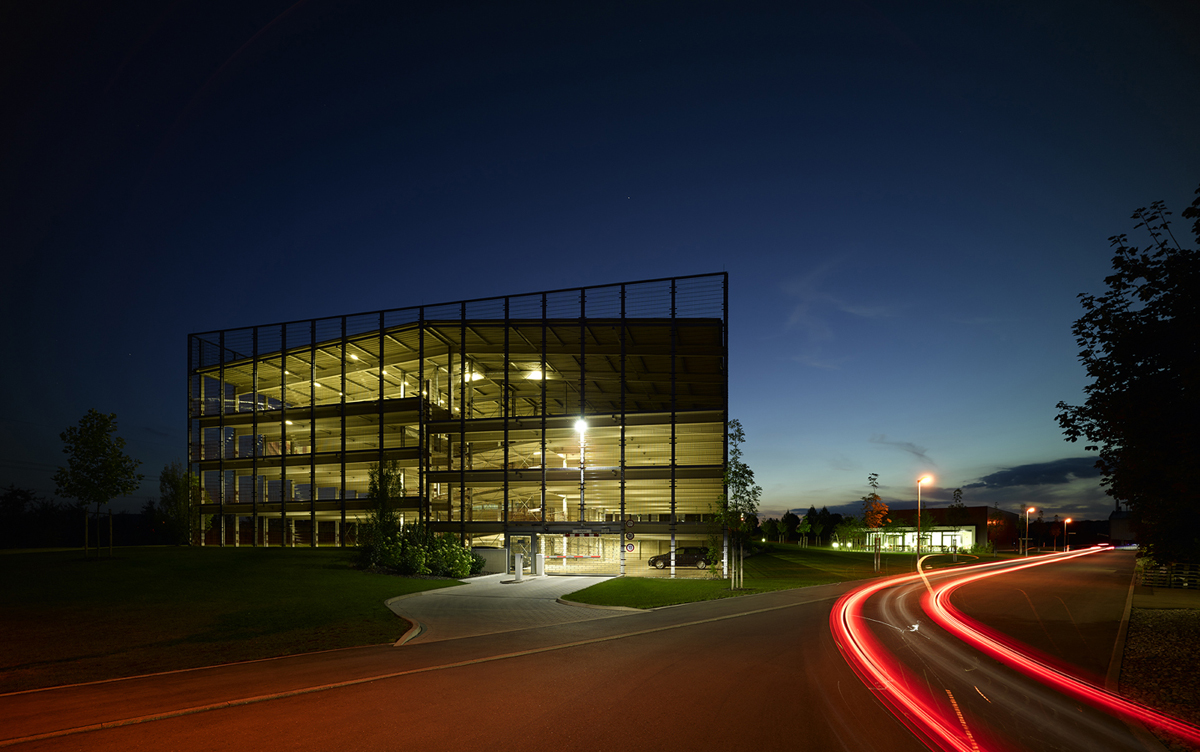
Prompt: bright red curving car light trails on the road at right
<box><xmin>829</xmin><ymin>547</ymin><xmax>1200</xmax><ymax>752</ymax></box>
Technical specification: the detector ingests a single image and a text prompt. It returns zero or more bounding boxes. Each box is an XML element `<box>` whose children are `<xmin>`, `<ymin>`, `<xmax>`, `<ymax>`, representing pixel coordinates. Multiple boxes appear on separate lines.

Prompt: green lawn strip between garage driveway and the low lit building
<box><xmin>564</xmin><ymin>543</ymin><xmax>1003</xmax><ymax>608</ymax></box>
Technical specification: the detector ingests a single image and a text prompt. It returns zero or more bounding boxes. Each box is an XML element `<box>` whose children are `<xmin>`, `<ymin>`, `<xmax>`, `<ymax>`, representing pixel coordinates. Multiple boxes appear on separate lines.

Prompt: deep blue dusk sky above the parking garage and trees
<box><xmin>0</xmin><ymin>0</ymin><xmax>1200</xmax><ymax>518</ymax></box>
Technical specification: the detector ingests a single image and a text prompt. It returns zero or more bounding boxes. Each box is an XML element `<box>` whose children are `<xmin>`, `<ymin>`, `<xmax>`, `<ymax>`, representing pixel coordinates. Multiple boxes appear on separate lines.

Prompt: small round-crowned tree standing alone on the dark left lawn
<box><xmin>54</xmin><ymin>408</ymin><xmax>143</xmax><ymax>554</ymax></box>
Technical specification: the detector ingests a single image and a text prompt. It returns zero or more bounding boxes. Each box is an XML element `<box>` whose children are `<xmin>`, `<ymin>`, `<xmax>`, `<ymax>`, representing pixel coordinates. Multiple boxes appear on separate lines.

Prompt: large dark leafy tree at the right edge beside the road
<box><xmin>1057</xmin><ymin>188</ymin><xmax>1200</xmax><ymax>561</ymax></box>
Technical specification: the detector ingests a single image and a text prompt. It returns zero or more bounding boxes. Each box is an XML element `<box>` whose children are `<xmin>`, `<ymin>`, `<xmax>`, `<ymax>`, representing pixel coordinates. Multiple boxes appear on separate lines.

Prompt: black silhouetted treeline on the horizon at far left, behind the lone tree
<box><xmin>0</xmin><ymin>486</ymin><xmax>169</xmax><ymax>548</ymax></box>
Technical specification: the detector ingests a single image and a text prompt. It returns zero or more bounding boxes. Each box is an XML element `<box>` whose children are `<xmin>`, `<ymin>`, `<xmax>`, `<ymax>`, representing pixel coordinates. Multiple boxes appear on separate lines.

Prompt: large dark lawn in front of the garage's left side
<box><xmin>0</xmin><ymin>547</ymin><xmax>457</xmax><ymax>692</ymax></box>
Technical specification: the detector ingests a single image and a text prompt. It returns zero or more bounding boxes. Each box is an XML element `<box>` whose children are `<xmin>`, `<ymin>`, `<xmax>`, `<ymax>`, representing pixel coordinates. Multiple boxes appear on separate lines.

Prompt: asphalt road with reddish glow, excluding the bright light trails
<box><xmin>0</xmin><ymin>546</ymin><xmax>1171</xmax><ymax>752</ymax></box>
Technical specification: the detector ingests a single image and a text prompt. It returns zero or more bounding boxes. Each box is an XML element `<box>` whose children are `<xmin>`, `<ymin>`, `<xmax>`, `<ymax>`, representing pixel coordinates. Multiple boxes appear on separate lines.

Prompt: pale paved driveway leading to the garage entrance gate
<box><xmin>388</xmin><ymin>574</ymin><xmax>631</xmax><ymax>644</ymax></box>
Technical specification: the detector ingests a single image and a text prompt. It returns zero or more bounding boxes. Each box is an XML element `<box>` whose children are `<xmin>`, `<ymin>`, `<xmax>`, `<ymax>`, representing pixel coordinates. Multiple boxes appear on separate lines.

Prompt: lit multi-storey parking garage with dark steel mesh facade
<box><xmin>188</xmin><ymin>273</ymin><xmax>728</xmax><ymax>573</ymax></box>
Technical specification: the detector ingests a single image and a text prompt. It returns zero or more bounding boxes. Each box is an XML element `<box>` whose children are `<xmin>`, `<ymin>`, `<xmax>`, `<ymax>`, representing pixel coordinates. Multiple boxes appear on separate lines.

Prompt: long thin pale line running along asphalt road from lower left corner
<box><xmin>0</xmin><ymin>594</ymin><xmax>840</xmax><ymax>747</ymax></box>
